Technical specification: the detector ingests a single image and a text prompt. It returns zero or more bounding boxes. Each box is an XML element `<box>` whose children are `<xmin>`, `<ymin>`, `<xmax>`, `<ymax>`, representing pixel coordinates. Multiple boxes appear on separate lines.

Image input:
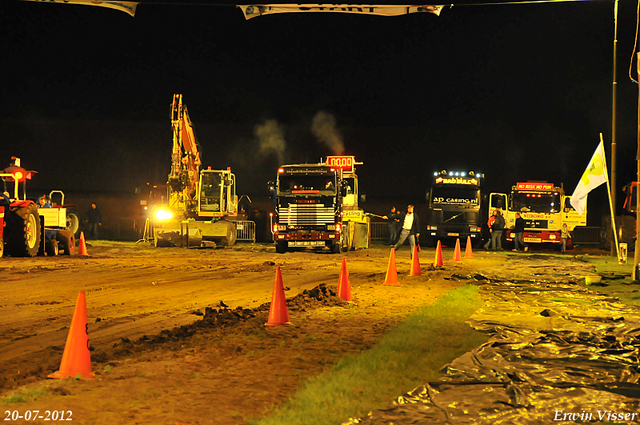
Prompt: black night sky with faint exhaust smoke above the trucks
<box><xmin>0</xmin><ymin>0</ymin><xmax>638</xmax><ymax>215</ymax></box>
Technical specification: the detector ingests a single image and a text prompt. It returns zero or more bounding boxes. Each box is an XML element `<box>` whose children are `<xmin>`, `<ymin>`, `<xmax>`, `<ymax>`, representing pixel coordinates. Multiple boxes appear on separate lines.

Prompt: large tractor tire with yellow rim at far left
<box><xmin>5</xmin><ymin>204</ymin><xmax>42</xmax><ymax>257</ymax></box>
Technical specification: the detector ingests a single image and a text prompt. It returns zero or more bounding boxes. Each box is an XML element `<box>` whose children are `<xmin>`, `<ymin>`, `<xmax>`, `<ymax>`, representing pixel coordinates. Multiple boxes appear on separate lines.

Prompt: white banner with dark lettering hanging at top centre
<box><xmin>238</xmin><ymin>4</ymin><xmax>444</xmax><ymax>19</ymax></box>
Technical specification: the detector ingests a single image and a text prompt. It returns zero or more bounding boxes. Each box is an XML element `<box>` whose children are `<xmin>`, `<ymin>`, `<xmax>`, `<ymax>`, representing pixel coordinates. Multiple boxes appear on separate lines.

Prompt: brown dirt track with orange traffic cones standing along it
<box><xmin>0</xmin><ymin>241</ymin><xmax>592</xmax><ymax>425</ymax></box>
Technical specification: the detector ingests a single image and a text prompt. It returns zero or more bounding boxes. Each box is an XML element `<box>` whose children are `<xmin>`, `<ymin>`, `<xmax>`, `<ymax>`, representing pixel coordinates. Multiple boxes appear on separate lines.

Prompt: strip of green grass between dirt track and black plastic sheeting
<box><xmin>248</xmin><ymin>286</ymin><xmax>488</xmax><ymax>425</ymax></box>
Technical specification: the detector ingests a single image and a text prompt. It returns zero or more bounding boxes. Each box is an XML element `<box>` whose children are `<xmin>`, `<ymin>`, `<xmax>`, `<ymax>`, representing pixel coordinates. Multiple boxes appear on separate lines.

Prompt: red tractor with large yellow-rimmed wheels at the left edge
<box><xmin>0</xmin><ymin>157</ymin><xmax>75</xmax><ymax>257</ymax></box>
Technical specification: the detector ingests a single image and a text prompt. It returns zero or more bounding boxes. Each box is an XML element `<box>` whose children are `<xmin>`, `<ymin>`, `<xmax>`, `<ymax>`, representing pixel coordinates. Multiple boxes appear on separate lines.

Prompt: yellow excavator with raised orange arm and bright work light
<box><xmin>151</xmin><ymin>94</ymin><xmax>238</xmax><ymax>247</ymax></box>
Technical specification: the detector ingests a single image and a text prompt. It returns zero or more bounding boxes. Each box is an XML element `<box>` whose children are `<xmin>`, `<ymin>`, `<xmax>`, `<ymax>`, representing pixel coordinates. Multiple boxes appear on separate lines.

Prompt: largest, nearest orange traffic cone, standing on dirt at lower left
<box><xmin>48</xmin><ymin>291</ymin><xmax>94</xmax><ymax>379</ymax></box>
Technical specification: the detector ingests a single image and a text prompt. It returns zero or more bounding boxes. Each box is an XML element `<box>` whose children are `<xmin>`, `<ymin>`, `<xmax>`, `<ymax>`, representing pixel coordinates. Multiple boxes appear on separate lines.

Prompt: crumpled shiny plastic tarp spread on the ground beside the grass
<box><xmin>346</xmin><ymin>264</ymin><xmax>640</xmax><ymax>425</ymax></box>
